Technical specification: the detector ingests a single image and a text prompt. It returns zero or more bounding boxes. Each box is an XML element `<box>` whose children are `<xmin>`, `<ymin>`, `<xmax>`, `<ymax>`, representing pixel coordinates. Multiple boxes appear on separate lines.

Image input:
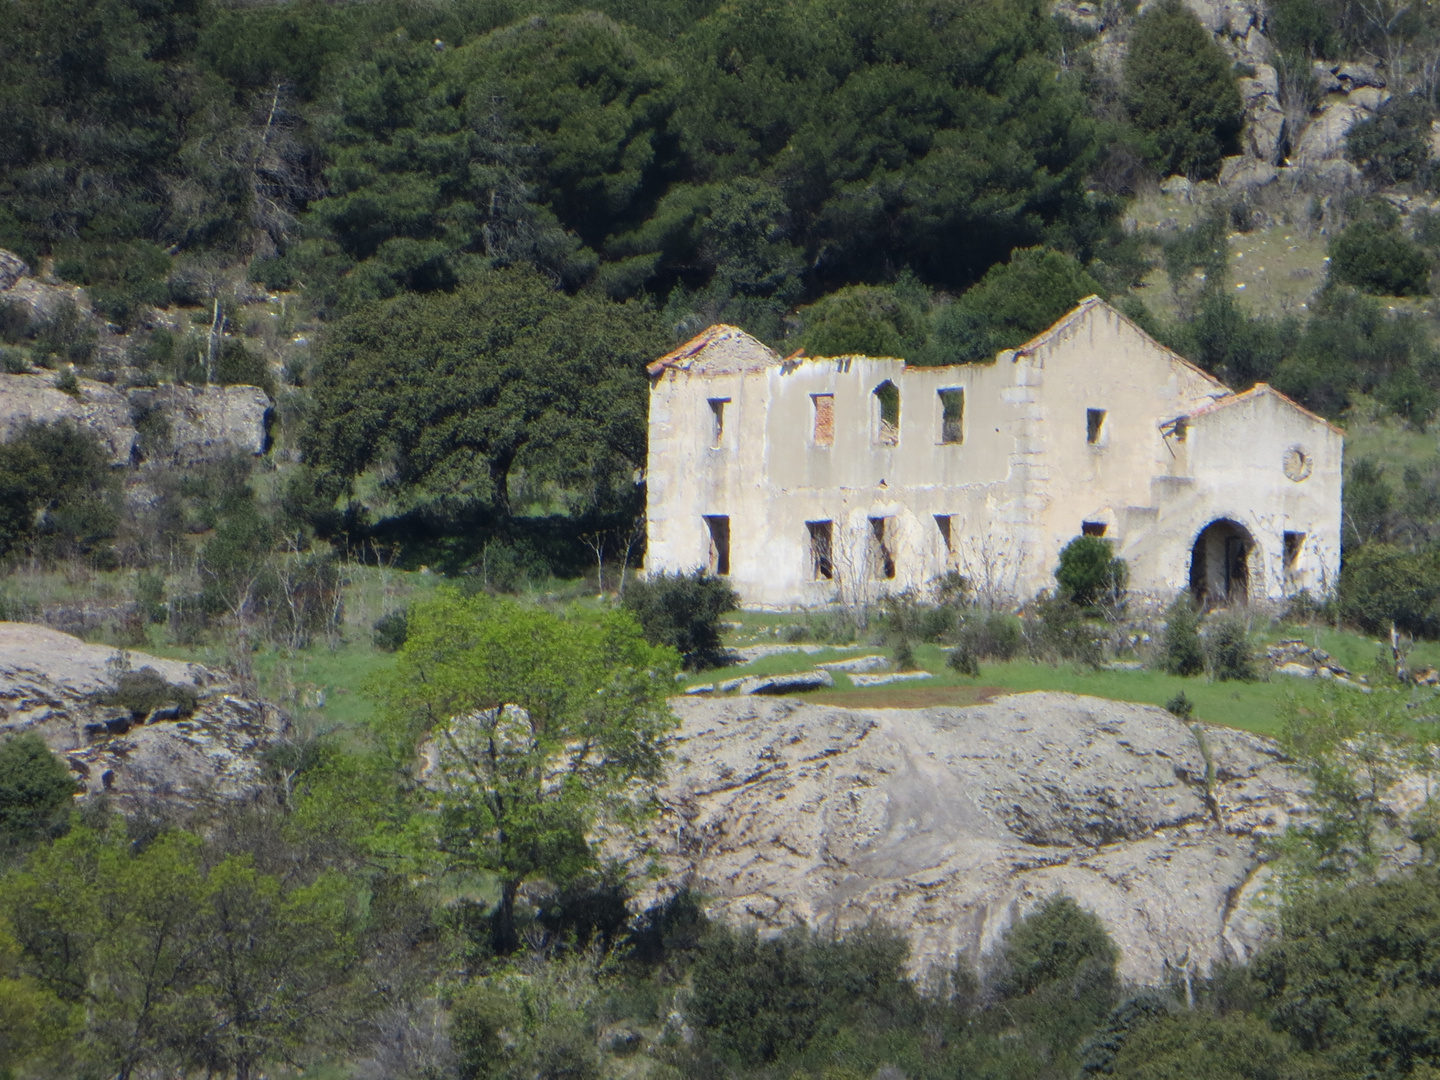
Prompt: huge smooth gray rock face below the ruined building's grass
<box><xmin>645</xmin><ymin>694</ymin><xmax>1303</xmax><ymax>982</ymax></box>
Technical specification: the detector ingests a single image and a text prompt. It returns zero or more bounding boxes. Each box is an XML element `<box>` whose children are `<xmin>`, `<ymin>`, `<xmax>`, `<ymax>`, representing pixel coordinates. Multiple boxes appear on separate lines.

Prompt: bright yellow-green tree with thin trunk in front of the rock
<box><xmin>379</xmin><ymin>592</ymin><xmax>678</xmax><ymax>952</ymax></box>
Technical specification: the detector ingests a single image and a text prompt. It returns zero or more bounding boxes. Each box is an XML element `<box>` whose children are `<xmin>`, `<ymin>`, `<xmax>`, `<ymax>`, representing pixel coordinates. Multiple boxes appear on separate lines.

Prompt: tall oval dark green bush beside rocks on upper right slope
<box><xmin>1123</xmin><ymin>0</ymin><xmax>1244</xmax><ymax>179</ymax></box>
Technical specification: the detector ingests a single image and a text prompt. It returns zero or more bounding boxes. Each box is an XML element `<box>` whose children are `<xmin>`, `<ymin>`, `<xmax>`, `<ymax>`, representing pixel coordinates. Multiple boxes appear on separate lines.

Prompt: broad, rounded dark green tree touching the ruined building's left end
<box><xmin>304</xmin><ymin>269</ymin><xmax>667</xmax><ymax>510</ymax></box>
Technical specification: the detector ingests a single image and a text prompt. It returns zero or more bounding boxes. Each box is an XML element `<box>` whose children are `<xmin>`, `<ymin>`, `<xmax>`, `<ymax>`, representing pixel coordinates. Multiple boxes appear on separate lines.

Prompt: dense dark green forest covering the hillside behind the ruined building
<box><xmin>8</xmin><ymin>0</ymin><xmax>1440</xmax><ymax>584</ymax></box>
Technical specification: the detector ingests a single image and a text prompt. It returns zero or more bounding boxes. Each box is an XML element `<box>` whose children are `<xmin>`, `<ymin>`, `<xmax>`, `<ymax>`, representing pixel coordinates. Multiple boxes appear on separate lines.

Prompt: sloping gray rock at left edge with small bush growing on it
<box><xmin>0</xmin><ymin>622</ymin><xmax>289</xmax><ymax>805</ymax></box>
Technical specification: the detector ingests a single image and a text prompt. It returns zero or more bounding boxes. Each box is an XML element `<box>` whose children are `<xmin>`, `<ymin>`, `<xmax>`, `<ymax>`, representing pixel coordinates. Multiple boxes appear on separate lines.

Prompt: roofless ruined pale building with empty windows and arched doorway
<box><xmin>647</xmin><ymin>297</ymin><xmax>1344</xmax><ymax>606</ymax></box>
